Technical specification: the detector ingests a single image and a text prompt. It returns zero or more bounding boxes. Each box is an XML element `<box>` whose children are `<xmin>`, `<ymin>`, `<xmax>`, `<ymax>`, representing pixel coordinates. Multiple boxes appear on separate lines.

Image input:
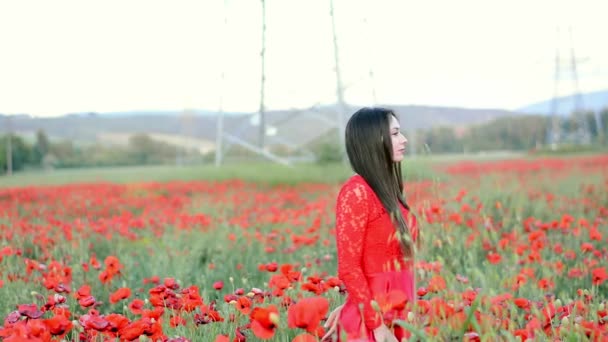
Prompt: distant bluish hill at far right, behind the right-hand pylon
<box><xmin>517</xmin><ymin>89</ymin><xmax>608</xmax><ymax>116</ymax></box>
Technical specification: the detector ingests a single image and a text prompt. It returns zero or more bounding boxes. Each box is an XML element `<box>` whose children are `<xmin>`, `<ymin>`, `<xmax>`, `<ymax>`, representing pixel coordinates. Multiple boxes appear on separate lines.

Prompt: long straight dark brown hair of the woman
<box><xmin>345</xmin><ymin>107</ymin><xmax>415</xmax><ymax>259</ymax></box>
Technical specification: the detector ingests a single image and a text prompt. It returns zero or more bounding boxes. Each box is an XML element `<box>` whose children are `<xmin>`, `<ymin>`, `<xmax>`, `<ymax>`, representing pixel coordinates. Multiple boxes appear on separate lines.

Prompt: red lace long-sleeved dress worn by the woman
<box><xmin>336</xmin><ymin>175</ymin><xmax>418</xmax><ymax>341</ymax></box>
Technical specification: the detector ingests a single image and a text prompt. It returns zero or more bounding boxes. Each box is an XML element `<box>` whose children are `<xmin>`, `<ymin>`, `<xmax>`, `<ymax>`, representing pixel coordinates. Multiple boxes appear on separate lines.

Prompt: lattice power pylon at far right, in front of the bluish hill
<box><xmin>547</xmin><ymin>27</ymin><xmax>590</xmax><ymax>149</ymax></box>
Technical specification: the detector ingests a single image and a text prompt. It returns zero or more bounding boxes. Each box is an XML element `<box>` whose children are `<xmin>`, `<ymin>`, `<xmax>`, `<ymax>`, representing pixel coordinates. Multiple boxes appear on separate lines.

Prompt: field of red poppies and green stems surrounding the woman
<box><xmin>0</xmin><ymin>155</ymin><xmax>608</xmax><ymax>342</ymax></box>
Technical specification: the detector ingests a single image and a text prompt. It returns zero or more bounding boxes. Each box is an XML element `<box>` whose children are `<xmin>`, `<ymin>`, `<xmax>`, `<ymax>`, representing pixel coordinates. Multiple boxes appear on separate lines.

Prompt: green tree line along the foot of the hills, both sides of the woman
<box><xmin>0</xmin><ymin>108</ymin><xmax>608</xmax><ymax>171</ymax></box>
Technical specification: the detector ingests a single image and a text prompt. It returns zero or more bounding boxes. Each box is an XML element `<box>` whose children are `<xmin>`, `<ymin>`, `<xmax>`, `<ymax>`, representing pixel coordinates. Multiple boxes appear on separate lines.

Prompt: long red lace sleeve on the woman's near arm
<box><xmin>336</xmin><ymin>183</ymin><xmax>382</xmax><ymax>329</ymax></box>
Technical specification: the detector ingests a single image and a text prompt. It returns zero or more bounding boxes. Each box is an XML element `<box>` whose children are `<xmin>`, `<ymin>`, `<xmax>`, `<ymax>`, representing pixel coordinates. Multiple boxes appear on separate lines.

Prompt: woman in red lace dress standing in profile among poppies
<box><xmin>324</xmin><ymin>108</ymin><xmax>418</xmax><ymax>342</ymax></box>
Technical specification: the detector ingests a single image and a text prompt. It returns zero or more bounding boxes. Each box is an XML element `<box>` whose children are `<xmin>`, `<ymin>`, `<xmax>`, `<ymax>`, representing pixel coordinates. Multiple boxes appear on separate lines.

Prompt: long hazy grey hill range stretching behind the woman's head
<box><xmin>0</xmin><ymin>105</ymin><xmax>521</xmax><ymax>150</ymax></box>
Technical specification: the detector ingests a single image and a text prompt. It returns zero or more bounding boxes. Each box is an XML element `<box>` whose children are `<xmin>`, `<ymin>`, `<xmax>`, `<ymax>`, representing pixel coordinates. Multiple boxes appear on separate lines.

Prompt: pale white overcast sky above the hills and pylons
<box><xmin>0</xmin><ymin>0</ymin><xmax>608</xmax><ymax>116</ymax></box>
